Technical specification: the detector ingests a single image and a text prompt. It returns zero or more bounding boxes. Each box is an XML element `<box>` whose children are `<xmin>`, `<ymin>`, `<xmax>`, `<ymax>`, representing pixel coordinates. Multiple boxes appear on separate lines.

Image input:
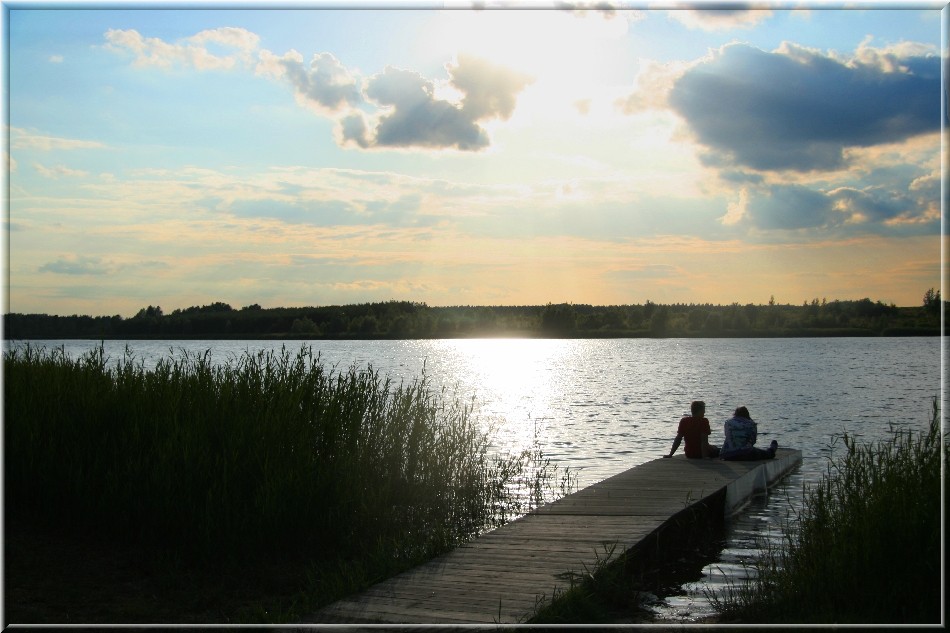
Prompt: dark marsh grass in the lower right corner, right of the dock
<box><xmin>707</xmin><ymin>400</ymin><xmax>950</xmax><ymax>624</ymax></box>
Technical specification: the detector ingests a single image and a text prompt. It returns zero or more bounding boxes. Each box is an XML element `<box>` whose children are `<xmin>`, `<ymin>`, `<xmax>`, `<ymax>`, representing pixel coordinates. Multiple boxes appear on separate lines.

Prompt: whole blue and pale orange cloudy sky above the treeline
<box><xmin>3</xmin><ymin>2</ymin><xmax>946</xmax><ymax>317</ymax></box>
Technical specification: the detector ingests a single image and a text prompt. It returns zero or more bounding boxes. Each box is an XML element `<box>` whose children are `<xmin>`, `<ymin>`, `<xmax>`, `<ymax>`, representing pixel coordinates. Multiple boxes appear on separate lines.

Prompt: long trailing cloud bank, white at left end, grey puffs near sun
<box><xmin>105</xmin><ymin>27</ymin><xmax>532</xmax><ymax>151</ymax></box>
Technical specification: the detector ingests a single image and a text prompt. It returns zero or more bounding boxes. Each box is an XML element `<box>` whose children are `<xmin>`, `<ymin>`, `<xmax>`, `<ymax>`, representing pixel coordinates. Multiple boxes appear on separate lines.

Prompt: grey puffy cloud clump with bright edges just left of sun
<box><xmin>340</xmin><ymin>57</ymin><xmax>530</xmax><ymax>150</ymax></box>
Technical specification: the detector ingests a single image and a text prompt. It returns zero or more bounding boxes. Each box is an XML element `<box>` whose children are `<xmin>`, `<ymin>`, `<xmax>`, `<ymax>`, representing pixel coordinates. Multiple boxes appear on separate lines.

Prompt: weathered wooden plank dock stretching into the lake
<box><xmin>309</xmin><ymin>449</ymin><xmax>802</xmax><ymax>625</ymax></box>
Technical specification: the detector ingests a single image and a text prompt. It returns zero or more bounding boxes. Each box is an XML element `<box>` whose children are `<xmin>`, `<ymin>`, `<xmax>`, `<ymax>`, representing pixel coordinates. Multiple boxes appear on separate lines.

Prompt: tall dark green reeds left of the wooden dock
<box><xmin>3</xmin><ymin>346</ymin><xmax>570</xmax><ymax>621</ymax></box>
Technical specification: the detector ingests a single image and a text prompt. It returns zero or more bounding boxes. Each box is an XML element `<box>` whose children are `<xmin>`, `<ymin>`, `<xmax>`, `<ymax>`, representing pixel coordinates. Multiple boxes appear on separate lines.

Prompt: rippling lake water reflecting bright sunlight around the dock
<box><xmin>4</xmin><ymin>337</ymin><xmax>942</xmax><ymax>622</ymax></box>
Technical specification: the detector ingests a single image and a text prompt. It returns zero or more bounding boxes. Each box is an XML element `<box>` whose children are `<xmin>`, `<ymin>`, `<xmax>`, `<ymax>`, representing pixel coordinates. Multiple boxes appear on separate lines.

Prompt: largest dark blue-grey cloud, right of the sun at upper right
<box><xmin>669</xmin><ymin>44</ymin><xmax>941</xmax><ymax>172</ymax></box>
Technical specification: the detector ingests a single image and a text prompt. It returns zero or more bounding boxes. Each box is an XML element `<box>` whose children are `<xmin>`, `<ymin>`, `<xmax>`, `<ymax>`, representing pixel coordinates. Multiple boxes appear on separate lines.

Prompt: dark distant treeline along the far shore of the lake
<box><xmin>3</xmin><ymin>289</ymin><xmax>944</xmax><ymax>340</ymax></box>
